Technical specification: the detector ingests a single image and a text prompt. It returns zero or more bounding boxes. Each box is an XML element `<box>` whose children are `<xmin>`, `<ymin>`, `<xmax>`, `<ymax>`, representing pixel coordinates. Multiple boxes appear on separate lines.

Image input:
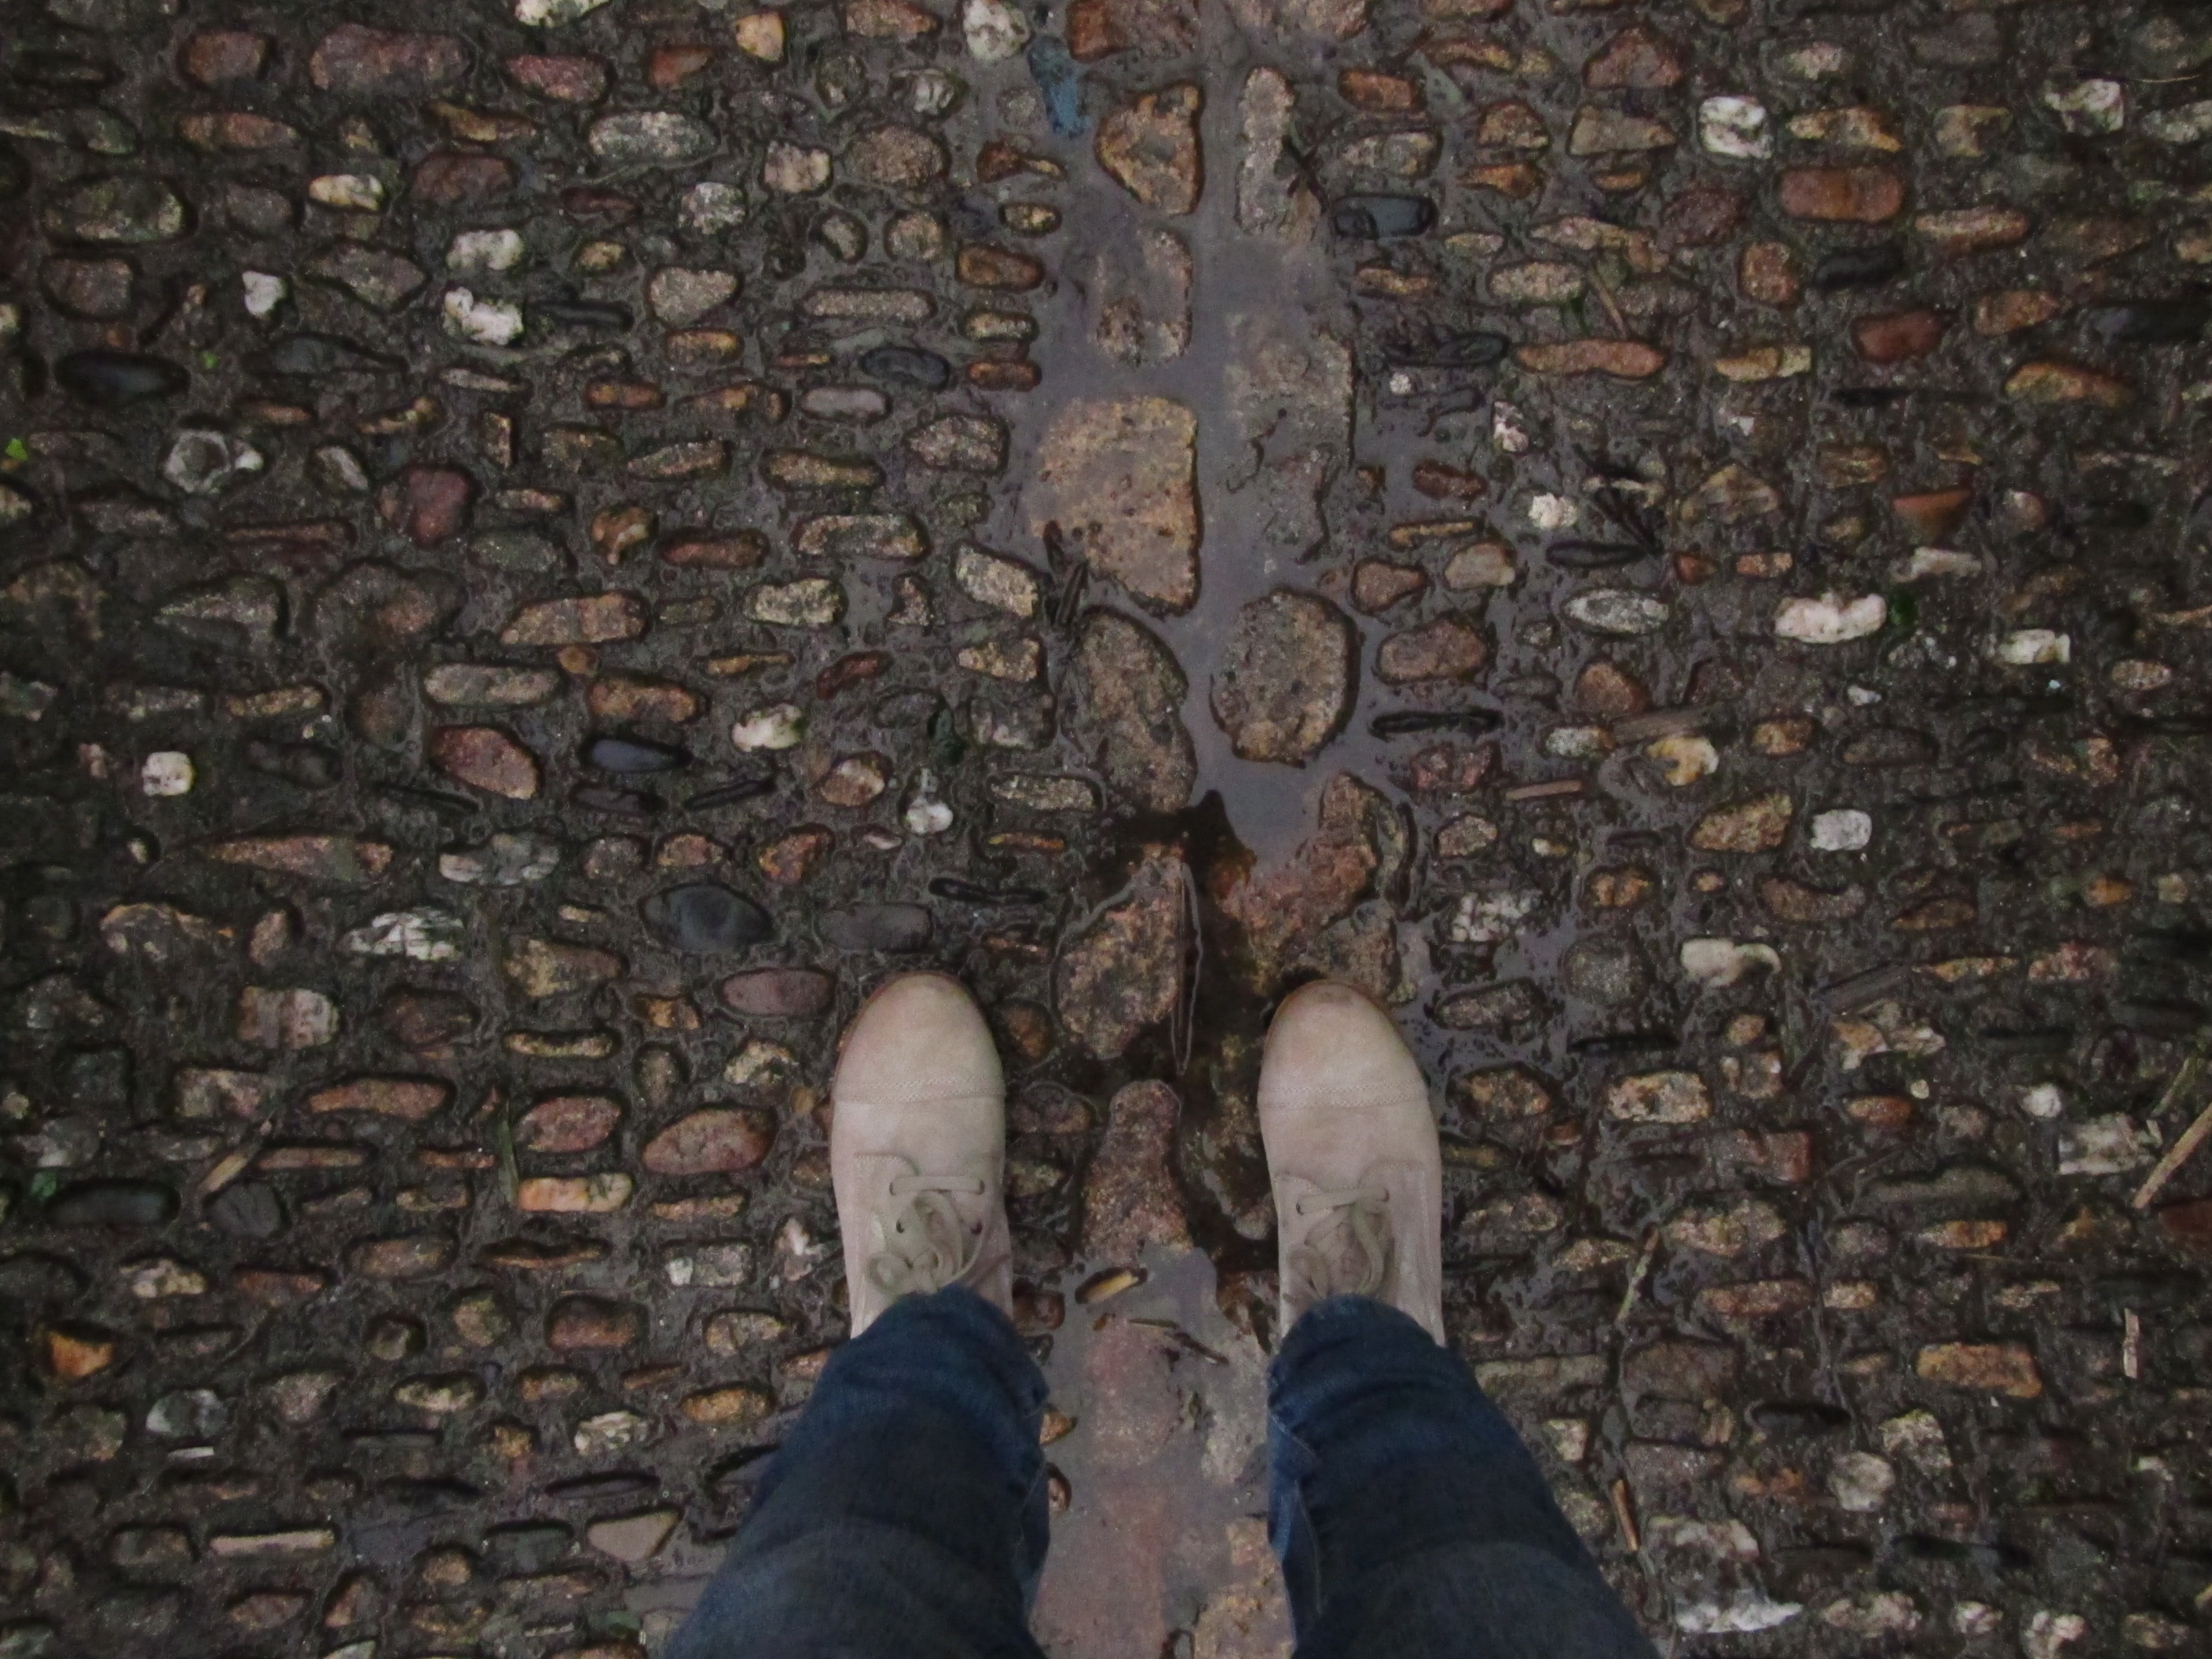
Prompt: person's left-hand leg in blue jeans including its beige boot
<box><xmin>668</xmin><ymin>973</ymin><xmax>1046</xmax><ymax>1659</ymax></box>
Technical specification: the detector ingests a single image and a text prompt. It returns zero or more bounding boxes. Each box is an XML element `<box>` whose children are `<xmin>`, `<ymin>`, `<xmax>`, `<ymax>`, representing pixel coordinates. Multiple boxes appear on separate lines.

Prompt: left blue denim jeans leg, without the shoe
<box><xmin>668</xmin><ymin>1287</ymin><xmax>1046</xmax><ymax>1659</ymax></box>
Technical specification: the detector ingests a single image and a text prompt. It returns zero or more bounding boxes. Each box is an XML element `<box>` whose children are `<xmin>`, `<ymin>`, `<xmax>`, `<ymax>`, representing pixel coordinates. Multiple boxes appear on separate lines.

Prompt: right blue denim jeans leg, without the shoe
<box><xmin>1268</xmin><ymin>1296</ymin><xmax>1650</xmax><ymax>1659</ymax></box>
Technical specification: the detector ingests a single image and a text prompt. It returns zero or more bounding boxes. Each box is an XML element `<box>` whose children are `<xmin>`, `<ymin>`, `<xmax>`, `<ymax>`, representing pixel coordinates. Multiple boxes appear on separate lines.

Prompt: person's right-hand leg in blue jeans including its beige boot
<box><xmin>1258</xmin><ymin>984</ymin><xmax>1650</xmax><ymax>1659</ymax></box>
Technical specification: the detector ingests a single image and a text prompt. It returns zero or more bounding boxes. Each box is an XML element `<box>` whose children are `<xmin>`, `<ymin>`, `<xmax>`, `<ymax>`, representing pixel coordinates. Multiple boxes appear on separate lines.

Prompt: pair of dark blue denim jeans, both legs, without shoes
<box><xmin>668</xmin><ymin>1290</ymin><xmax>1653</xmax><ymax>1659</ymax></box>
